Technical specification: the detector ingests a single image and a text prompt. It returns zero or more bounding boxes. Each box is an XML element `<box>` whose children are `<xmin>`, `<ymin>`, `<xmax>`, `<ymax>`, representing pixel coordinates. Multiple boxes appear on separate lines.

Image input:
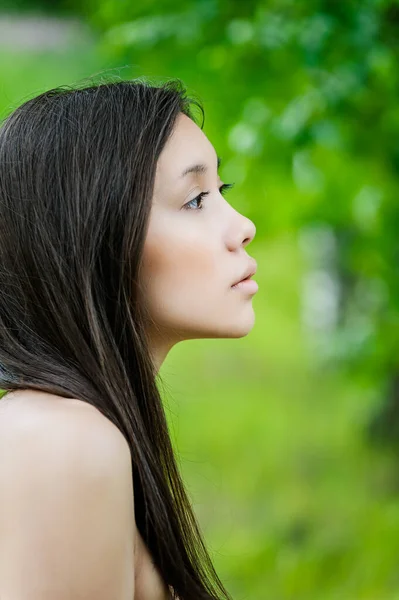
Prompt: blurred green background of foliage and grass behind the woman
<box><xmin>0</xmin><ymin>0</ymin><xmax>399</xmax><ymax>600</ymax></box>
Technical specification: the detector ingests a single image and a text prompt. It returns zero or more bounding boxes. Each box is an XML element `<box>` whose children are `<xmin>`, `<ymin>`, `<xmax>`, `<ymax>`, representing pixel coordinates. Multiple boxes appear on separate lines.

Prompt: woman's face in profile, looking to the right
<box><xmin>140</xmin><ymin>113</ymin><xmax>256</xmax><ymax>366</ymax></box>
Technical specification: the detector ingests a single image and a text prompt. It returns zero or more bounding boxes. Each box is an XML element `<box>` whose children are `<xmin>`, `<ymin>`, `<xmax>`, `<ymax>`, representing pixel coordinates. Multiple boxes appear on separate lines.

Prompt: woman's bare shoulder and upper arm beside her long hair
<box><xmin>0</xmin><ymin>395</ymin><xmax>135</xmax><ymax>600</ymax></box>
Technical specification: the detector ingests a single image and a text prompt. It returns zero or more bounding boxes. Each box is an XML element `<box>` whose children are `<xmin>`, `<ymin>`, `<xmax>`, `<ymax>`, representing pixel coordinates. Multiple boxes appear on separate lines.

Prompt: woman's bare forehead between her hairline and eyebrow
<box><xmin>157</xmin><ymin>114</ymin><xmax>217</xmax><ymax>184</ymax></box>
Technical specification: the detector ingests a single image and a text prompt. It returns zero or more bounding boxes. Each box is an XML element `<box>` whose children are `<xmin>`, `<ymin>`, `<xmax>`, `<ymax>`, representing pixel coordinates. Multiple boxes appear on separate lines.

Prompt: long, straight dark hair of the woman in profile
<box><xmin>0</xmin><ymin>79</ymin><xmax>231</xmax><ymax>600</ymax></box>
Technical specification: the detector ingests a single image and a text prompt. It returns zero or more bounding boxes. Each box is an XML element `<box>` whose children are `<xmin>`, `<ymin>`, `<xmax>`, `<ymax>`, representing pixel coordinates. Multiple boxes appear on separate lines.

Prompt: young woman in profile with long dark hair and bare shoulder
<box><xmin>0</xmin><ymin>79</ymin><xmax>256</xmax><ymax>600</ymax></box>
